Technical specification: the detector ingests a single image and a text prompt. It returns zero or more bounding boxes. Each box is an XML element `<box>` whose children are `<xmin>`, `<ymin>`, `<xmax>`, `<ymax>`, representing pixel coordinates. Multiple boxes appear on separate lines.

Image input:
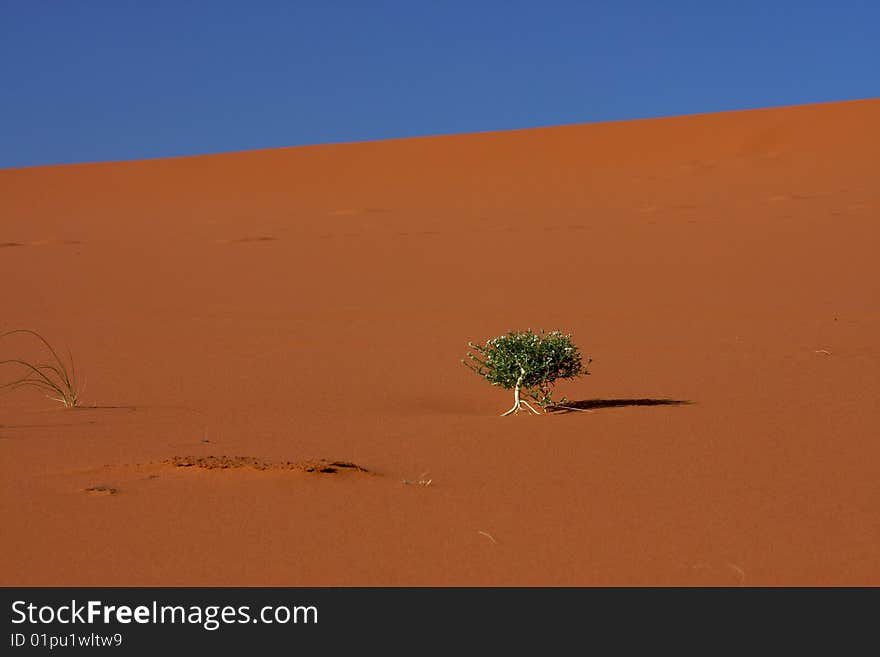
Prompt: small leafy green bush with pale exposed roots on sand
<box><xmin>462</xmin><ymin>329</ymin><xmax>592</xmax><ymax>415</ymax></box>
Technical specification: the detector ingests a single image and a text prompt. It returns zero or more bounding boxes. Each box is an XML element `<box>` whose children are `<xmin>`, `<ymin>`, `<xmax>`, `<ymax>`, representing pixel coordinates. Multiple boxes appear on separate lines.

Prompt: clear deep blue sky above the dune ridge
<box><xmin>0</xmin><ymin>0</ymin><xmax>880</xmax><ymax>168</ymax></box>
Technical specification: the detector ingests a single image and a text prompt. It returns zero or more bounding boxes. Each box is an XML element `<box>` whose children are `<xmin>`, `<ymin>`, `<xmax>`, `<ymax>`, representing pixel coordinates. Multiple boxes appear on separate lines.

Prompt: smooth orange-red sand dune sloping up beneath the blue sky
<box><xmin>0</xmin><ymin>100</ymin><xmax>880</xmax><ymax>586</ymax></box>
